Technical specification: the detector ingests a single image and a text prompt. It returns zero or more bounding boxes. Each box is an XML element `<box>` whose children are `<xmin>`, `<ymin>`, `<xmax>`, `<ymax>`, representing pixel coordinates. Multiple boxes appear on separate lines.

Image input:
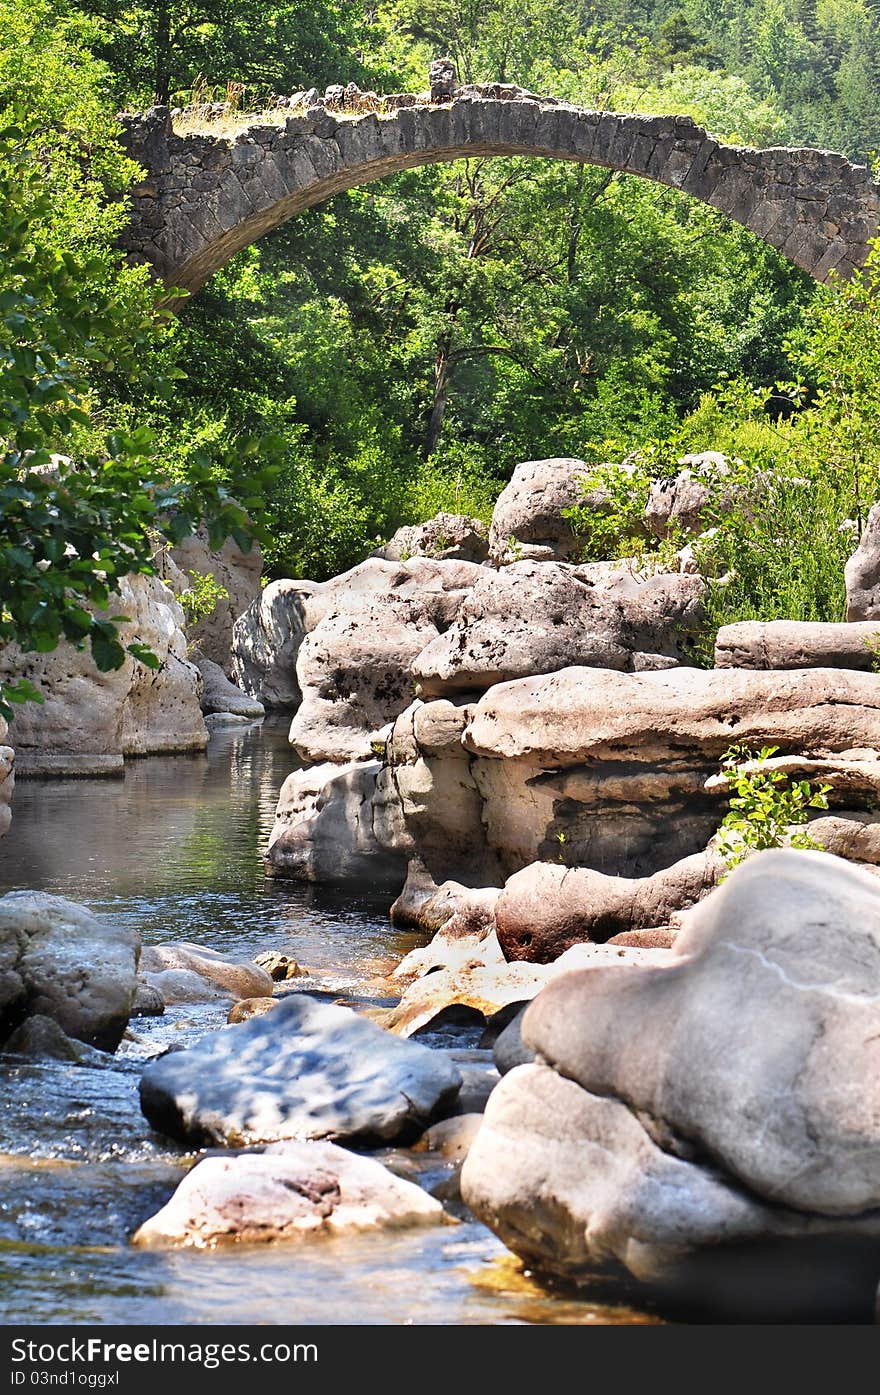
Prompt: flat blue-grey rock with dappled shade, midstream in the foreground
<box><xmin>141</xmin><ymin>993</ymin><xmax>462</xmax><ymax>1145</ymax></box>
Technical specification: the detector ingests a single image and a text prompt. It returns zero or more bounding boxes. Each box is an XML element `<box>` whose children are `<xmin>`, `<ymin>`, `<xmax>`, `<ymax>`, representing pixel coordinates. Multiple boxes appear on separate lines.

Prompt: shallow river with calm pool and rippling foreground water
<box><xmin>0</xmin><ymin>724</ymin><xmax>650</xmax><ymax>1325</ymax></box>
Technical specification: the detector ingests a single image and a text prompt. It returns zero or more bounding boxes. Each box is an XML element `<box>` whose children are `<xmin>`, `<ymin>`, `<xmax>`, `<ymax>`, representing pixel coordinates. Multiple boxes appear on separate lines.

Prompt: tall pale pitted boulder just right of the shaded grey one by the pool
<box><xmin>290</xmin><ymin>558</ymin><xmax>484</xmax><ymax>763</ymax></box>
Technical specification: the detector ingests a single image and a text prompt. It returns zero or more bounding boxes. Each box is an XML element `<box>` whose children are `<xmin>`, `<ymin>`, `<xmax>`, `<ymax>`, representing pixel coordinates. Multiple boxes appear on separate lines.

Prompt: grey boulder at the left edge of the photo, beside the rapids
<box><xmin>0</xmin><ymin>891</ymin><xmax>141</xmax><ymax>1050</ymax></box>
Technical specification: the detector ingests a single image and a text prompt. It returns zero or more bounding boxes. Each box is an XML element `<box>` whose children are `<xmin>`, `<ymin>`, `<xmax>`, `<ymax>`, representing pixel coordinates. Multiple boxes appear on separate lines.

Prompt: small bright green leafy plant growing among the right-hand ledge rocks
<box><xmin>717</xmin><ymin>745</ymin><xmax>831</xmax><ymax>869</ymax></box>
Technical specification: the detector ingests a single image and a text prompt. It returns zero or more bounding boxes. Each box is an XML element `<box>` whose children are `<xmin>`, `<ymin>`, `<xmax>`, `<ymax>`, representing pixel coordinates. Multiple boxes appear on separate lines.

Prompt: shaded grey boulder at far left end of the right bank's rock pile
<box><xmin>230</xmin><ymin>580</ymin><xmax>318</xmax><ymax>711</ymax></box>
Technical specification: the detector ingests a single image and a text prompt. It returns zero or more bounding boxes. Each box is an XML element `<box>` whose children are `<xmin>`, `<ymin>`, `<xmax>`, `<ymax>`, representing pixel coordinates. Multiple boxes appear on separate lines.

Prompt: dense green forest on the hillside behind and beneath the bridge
<box><xmin>0</xmin><ymin>0</ymin><xmax>880</xmax><ymax>680</ymax></box>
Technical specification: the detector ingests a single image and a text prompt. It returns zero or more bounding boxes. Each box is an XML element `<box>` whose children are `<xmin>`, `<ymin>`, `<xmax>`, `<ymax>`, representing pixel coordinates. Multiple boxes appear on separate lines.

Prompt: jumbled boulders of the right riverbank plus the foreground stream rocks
<box><xmin>0</xmin><ymin>460</ymin><xmax>880</xmax><ymax>1320</ymax></box>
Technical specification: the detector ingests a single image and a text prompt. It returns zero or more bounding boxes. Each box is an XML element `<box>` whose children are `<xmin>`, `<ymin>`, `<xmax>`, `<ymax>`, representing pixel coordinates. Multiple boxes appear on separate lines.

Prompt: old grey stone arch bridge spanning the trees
<box><xmin>121</xmin><ymin>74</ymin><xmax>880</xmax><ymax>292</ymax></box>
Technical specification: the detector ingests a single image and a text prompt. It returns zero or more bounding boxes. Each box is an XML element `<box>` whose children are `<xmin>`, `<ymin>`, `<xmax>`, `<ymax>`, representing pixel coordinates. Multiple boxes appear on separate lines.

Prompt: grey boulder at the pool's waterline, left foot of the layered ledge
<box><xmin>265</xmin><ymin>760</ymin><xmax>406</xmax><ymax>891</ymax></box>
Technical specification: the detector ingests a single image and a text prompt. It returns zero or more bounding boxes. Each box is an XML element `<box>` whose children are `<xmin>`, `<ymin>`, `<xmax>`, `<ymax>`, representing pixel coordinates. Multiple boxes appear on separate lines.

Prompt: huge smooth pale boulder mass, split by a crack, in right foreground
<box><xmin>462</xmin><ymin>851</ymin><xmax>880</xmax><ymax>1316</ymax></box>
